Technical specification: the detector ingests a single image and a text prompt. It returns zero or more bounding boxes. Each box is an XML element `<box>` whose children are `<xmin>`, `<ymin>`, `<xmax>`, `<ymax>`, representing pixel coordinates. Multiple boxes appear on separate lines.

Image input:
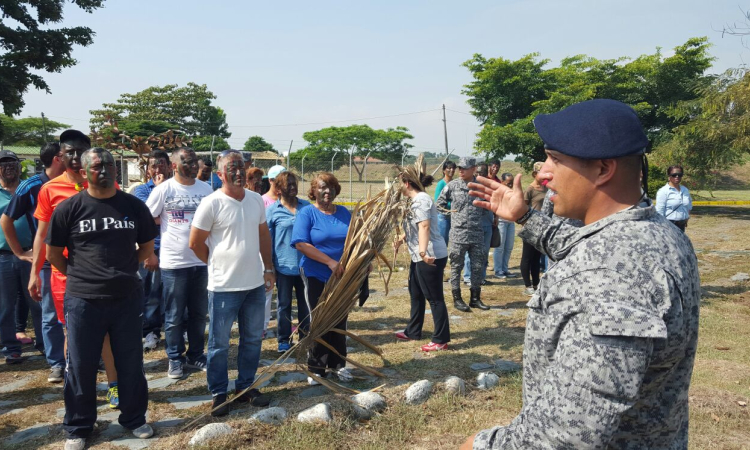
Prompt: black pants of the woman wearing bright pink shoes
<box><xmin>405</xmin><ymin>257</ymin><xmax>451</xmax><ymax>344</ymax></box>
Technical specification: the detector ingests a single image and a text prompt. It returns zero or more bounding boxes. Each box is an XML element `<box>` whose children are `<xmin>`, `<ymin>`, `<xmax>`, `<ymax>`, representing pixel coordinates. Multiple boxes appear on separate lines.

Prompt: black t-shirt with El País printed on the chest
<box><xmin>46</xmin><ymin>190</ymin><xmax>159</xmax><ymax>299</ymax></box>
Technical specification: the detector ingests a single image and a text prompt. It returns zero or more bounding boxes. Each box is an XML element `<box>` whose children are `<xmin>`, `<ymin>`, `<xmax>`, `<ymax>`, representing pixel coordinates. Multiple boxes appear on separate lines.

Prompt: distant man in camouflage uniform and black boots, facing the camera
<box><xmin>437</xmin><ymin>157</ymin><xmax>490</xmax><ymax>312</ymax></box>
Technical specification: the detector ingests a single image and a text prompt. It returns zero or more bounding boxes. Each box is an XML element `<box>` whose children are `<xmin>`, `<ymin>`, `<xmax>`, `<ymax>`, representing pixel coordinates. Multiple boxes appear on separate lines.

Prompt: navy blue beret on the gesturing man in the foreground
<box><xmin>534</xmin><ymin>99</ymin><xmax>648</xmax><ymax>159</ymax></box>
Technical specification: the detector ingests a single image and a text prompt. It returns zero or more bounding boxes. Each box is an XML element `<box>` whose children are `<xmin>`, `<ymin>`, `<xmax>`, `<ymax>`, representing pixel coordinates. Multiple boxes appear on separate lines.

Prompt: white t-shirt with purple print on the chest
<box><xmin>146</xmin><ymin>178</ymin><xmax>213</xmax><ymax>269</ymax></box>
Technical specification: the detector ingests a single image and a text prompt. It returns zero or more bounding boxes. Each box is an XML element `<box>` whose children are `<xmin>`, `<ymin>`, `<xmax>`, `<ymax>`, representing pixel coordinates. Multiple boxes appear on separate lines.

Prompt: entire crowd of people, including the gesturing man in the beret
<box><xmin>0</xmin><ymin>96</ymin><xmax>700</xmax><ymax>450</ymax></box>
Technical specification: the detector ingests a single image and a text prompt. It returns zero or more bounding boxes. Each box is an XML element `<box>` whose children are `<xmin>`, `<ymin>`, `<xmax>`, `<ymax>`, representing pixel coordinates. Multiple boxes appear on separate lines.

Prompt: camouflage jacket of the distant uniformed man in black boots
<box><xmin>437</xmin><ymin>178</ymin><xmax>492</xmax><ymax>244</ymax></box>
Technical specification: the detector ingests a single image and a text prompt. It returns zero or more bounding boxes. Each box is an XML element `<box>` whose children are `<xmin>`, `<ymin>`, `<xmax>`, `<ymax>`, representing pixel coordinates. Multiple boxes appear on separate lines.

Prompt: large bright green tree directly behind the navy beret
<box><xmin>462</xmin><ymin>38</ymin><xmax>713</xmax><ymax>168</ymax></box>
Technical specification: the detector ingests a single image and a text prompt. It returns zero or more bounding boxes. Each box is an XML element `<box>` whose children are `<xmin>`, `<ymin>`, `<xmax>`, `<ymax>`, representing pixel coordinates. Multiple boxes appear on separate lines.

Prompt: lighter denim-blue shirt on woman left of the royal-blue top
<box><xmin>266</xmin><ymin>199</ymin><xmax>310</xmax><ymax>276</ymax></box>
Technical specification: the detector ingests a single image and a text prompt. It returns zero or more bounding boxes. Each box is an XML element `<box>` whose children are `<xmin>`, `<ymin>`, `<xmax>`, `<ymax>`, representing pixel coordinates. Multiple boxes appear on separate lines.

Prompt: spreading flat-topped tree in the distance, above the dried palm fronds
<box><xmin>291</xmin><ymin>125</ymin><xmax>414</xmax><ymax>181</ymax></box>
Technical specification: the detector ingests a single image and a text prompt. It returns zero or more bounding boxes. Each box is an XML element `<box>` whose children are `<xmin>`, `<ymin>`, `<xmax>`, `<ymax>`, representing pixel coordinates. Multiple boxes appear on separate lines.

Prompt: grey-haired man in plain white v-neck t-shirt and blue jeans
<box><xmin>190</xmin><ymin>150</ymin><xmax>275</xmax><ymax>416</ymax></box>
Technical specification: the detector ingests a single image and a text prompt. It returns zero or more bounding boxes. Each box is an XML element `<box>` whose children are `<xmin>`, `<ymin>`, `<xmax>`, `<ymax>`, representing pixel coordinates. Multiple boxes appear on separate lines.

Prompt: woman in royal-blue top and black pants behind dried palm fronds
<box><xmin>292</xmin><ymin>172</ymin><xmax>352</xmax><ymax>385</ymax></box>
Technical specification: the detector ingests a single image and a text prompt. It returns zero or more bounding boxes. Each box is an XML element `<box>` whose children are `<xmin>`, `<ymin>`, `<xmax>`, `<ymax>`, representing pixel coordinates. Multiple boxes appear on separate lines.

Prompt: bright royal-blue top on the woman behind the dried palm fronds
<box><xmin>292</xmin><ymin>205</ymin><xmax>352</xmax><ymax>283</ymax></box>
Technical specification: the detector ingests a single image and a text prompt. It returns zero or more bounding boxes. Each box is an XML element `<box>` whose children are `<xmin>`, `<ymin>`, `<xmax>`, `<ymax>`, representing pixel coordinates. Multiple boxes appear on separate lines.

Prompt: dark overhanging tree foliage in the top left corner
<box><xmin>0</xmin><ymin>0</ymin><xmax>104</xmax><ymax>139</ymax></box>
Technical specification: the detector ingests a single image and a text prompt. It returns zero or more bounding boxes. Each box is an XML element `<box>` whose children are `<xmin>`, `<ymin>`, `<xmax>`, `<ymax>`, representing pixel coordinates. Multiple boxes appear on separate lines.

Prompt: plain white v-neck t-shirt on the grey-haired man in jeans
<box><xmin>193</xmin><ymin>189</ymin><xmax>266</xmax><ymax>292</ymax></box>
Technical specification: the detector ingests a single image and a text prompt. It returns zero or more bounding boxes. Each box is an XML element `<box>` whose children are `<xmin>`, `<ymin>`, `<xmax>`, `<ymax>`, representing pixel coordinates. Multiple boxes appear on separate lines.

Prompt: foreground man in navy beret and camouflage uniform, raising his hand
<box><xmin>462</xmin><ymin>100</ymin><xmax>700</xmax><ymax>450</ymax></box>
